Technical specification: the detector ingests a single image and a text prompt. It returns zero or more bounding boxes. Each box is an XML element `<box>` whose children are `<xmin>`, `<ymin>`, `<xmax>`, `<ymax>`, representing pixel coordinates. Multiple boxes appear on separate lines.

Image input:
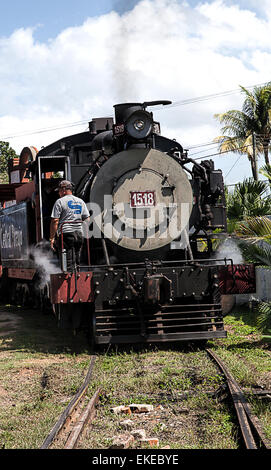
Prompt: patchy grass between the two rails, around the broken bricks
<box><xmin>81</xmin><ymin>348</ymin><xmax>236</xmax><ymax>449</ymax></box>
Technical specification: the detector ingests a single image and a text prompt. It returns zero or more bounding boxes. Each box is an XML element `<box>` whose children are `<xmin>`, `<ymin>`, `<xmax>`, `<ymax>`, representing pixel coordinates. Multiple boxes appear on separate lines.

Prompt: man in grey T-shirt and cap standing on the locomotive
<box><xmin>50</xmin><ymin>180</ymin><xmax>90</xmax><ymax>271</ymax></box>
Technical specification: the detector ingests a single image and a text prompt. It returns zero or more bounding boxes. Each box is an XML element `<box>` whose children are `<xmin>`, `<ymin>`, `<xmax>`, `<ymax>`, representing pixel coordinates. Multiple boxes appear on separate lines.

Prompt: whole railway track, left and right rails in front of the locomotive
<box><xmin>41</xmin><ymin>349</ymin><xmax>271</xmax><ymax>449</ymax></box>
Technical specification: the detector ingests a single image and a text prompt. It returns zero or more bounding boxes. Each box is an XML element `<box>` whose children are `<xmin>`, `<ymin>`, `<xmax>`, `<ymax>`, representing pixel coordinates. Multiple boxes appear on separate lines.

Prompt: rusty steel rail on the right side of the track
<box><xmin>206</xmin><ymin>349</ymin><xmax>270</xmax><ymax>449</ymax></box>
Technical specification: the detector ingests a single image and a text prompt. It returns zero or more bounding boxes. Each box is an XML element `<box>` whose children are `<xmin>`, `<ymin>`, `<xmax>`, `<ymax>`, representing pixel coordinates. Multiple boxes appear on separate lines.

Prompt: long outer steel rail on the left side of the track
<box><xmin>40</xmin><ymin>356</ymin><xmax>99</xmax><ymax>449</ymax></box>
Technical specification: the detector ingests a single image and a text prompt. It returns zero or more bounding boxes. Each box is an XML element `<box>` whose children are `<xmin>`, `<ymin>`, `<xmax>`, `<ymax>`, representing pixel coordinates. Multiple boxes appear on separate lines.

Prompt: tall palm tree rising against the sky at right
<box><xmin>215</xmin><ymin>82</ymin><xmax>271</xmax><ymax>180</ymax></box>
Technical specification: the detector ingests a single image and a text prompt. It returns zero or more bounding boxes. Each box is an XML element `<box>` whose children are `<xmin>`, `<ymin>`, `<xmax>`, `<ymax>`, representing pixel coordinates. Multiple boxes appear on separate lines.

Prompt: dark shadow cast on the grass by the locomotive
<box><xmin>0</xmin><ymin>305</ymin><xmax>210</xmax><ymax>355</ymax></box>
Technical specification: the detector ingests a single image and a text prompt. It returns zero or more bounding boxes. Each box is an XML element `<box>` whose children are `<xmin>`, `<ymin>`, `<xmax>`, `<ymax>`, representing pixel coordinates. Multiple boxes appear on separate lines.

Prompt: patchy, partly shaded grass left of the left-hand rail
<box><xmin>0</xmin><ymin>307</ymin><xmax>89</xmax><ymax>449</ymax></box>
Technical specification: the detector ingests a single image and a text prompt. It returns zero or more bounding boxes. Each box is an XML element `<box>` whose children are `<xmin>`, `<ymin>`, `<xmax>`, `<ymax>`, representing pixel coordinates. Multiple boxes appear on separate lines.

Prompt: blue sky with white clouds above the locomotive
<box><xmin>0</xmin><ymin>0</ymin><xmax>271</xmax><ymax>185</ymax></box>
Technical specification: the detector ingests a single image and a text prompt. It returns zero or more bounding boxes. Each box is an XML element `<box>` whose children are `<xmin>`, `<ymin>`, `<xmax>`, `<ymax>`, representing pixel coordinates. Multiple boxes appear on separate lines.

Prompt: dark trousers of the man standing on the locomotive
<box><xmin>59</xmin><ymin>231</ymin><xmax>83</xmax><ymax>271</ymax></box>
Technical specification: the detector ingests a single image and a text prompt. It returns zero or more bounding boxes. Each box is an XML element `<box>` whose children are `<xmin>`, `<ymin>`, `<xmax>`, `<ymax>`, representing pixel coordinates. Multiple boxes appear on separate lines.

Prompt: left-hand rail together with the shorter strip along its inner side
<box><xmin>41</xmin><ymin>356</ymin><xmax>100</xmax><ymax>449</ymax></box>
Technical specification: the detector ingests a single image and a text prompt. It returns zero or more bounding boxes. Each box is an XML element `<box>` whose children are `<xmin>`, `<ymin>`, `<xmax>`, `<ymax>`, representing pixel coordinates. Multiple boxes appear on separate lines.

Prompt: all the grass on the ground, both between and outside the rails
<box><xmin>0</xmin><ymin>302</ymin><xmax>271</xmax><ymax>449</ymax></box>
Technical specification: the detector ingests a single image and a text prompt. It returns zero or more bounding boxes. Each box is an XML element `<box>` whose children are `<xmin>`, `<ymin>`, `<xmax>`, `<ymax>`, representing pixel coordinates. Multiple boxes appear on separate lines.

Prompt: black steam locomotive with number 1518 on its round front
<box><xmin>0</xmin><ymin>101</ymin><xmax>254</xmax><ymax>344</ymax></box>
